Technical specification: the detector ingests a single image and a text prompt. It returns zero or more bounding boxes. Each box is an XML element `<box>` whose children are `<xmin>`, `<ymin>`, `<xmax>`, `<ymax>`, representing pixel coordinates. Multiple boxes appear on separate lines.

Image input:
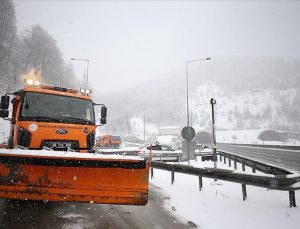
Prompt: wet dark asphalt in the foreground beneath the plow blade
<box><xmin>0</xmin><ymin>186</ymin><xmax>196</xmax><ymax>229</ymax></box>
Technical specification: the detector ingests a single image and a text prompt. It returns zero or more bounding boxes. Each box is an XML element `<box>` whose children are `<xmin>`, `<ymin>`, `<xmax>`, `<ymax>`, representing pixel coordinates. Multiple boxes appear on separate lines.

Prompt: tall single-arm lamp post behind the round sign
<box><xmin>185</xmin><ymin>57</ymin><xmax>211</xmax><ymax>165</ymax></box>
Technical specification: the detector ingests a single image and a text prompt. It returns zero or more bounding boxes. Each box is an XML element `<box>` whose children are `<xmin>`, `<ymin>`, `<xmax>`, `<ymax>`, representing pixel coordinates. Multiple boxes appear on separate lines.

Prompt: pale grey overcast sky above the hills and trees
<box><xmin>15</xmin><ymin>0</ymin><xmax>300</xmax><ymax>93</ymax></box>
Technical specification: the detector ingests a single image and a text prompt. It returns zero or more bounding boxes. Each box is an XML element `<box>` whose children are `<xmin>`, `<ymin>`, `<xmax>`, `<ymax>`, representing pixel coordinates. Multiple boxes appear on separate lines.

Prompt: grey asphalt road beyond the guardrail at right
<box><xmin>217</xmin><ymin>143</ymin><xmax>300</xmax><ymax>173</ymax></box>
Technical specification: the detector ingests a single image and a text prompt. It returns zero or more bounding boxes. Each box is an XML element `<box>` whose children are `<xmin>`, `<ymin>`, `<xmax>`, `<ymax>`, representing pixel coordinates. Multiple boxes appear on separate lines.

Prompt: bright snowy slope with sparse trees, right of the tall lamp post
<box><xmin>190</xmin><ymin>82</ymin><xmax>297</xmax><ymax>129</ymax></box>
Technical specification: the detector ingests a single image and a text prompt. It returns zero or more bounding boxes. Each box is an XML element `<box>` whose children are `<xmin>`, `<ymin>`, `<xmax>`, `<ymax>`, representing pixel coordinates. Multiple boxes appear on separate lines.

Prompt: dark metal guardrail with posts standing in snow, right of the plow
<box><xmin>151</xmin><ymin>161</ymin><xmax>300</xmax><ymax>207</ymax></box>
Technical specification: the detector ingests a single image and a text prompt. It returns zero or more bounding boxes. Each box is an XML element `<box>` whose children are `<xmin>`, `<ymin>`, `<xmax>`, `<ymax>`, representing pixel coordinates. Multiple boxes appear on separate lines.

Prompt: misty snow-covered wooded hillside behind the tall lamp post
<box><xmin>98</xmin><ymin>58</ymin><xmax>300</xmax><ymax>135</ymax></box>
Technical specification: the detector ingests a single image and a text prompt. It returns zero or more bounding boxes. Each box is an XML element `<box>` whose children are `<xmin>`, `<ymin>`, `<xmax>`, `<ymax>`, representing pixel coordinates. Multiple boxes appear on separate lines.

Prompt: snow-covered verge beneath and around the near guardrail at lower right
<box><xmin>150</xmin><ymin>160</ymin><xmax>300</xmax><ymax>229</ymax></box>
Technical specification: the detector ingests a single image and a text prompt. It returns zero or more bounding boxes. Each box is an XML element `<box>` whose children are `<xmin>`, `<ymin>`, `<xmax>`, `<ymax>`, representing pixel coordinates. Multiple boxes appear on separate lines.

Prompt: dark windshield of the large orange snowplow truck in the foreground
<box><xmin>20</xmin><ymin>92</ymin><xmax>95</xmax><ymax>124</ymax></box>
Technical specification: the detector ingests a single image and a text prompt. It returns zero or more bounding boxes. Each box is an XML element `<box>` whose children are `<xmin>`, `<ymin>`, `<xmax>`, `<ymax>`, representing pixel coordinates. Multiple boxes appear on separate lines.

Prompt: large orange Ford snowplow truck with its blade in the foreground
<box><xmin>0</xmin><ymin>81</ymin><xmax>149</xmax><ymax>205</ymax></box>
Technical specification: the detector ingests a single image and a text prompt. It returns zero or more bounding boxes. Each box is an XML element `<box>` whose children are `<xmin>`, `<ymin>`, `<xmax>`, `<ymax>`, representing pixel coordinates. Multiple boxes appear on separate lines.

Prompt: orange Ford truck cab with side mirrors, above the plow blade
<box><xmin>0</xmin><ymin>79</ymin><xmax>107</xmax><ymax>152</ymax></box>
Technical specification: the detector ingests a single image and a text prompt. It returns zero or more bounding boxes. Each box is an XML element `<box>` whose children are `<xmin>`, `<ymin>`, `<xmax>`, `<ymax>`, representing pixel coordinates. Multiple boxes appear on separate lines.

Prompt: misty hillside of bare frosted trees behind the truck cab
<box><xmin>0</xmin><ymin>0</ymin><xmax>78</xmax><ymax>93</ymax></box>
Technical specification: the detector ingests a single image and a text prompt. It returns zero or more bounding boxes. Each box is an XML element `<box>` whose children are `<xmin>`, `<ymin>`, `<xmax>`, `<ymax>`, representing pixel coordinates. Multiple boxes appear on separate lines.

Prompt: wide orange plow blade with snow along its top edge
<box><xmin>0</xmin><ymin>149</ymin><xmax>149</xmax><ymax>205</ymax></box>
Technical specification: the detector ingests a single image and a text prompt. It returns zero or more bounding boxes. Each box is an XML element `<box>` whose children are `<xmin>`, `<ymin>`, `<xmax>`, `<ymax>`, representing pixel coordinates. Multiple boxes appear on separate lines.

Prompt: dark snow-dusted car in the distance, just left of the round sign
<box><xmin>141</xmin><ymin>144</ymin><xmax>182</xmax><ymax>161</ymax></box>
